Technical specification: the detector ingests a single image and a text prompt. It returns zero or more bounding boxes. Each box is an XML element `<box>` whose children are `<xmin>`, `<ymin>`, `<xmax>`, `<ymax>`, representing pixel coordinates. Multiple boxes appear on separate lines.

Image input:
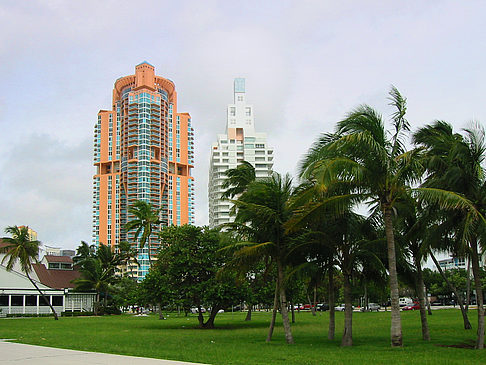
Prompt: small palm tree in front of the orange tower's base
<box><xmin>125</xmin><ymin>200</ymin><xmax>160</xmax><ymax>267</ymax></box>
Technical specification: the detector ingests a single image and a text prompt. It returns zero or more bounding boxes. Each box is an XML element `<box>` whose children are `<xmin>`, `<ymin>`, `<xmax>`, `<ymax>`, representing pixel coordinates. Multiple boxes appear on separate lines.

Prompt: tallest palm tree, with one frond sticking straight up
<box><xmin>301</xmin><ymin>87</ymin><xmax>421</xmax><ymax>346</ymax></box>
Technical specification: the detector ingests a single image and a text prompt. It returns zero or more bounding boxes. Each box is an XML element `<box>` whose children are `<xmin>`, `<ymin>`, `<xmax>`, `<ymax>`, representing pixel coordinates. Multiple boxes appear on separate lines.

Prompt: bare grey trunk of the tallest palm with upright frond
<box><xmin>384</xmin><ymin>206</ymin><xmax>403</xmax><ymax>347</ymax></box>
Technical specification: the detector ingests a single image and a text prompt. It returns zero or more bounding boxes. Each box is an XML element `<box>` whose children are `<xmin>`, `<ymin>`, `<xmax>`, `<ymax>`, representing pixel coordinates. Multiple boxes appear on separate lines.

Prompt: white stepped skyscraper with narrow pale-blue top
<box><xmin>208</xmin><ymin>78</ymin><xmax>273</xmax><ymax>227</ymax></box>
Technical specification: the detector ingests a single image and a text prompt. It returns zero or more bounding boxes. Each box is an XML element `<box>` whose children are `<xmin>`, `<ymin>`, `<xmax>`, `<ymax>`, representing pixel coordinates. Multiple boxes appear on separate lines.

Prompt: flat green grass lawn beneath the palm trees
<box><xmin>0</xmin><ymin>309</ymin><xmax>486</xmax><ymax>365</ymax></box>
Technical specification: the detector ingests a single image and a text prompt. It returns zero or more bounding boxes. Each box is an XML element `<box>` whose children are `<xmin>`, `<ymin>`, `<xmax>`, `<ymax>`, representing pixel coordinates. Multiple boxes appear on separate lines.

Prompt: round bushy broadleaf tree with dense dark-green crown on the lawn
<box><xmin>153</xmin><ymin>225</ymin><xmax>245</xmax><ymax>328</ymax></box>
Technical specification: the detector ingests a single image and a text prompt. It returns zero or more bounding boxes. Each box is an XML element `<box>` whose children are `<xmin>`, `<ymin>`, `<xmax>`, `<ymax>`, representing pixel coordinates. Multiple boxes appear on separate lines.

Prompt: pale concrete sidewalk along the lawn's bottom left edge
<box><xmin>0</xmin><ymin>340</ymin><xmax>200</xmax><ymax>365</ymax></box>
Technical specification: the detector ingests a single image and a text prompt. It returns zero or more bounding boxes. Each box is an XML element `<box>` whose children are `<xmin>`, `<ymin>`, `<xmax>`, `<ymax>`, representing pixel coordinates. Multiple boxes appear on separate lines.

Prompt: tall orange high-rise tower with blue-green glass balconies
<box><xmin>93</xmin><ymin>62</ymin><xmax>194</xmax><ymax>278</ymax></box>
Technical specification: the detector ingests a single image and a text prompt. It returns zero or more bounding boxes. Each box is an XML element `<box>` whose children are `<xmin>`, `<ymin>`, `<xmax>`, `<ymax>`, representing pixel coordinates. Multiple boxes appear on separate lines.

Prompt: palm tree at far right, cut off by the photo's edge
<box><xmin>414</xmin><ymin>121</ymin><xmax>486</xmax><ymax>349</ymax></box>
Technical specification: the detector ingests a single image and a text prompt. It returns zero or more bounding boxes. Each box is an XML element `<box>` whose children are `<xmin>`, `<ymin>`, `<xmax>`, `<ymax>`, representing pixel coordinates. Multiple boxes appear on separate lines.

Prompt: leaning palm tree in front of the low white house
<box><xmin>0</xmin><ymin>226</ymin><xmax>59</xmax><ymax>320</ymax></box>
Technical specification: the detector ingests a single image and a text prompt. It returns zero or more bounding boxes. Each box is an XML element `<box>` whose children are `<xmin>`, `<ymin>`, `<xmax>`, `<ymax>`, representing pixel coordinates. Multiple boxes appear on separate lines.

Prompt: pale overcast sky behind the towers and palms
<box><xmin>0</xmin><ymin>0</ymin><xmax>486</xmax><ymax>248</ymax></box>
